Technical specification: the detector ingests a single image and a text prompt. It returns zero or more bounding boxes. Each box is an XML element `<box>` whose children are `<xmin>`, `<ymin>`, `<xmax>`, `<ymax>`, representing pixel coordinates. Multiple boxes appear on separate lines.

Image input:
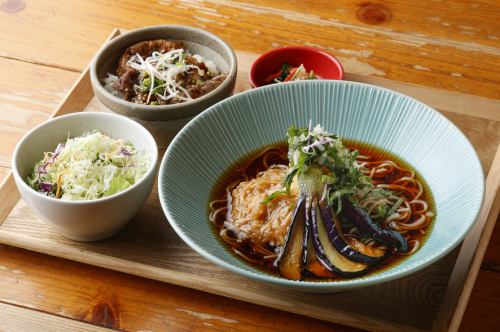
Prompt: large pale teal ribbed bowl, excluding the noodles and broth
<box><xmin>159</xmin><ymin>81</ymin><xmax>484</xmax><ymax>292</ymax></box>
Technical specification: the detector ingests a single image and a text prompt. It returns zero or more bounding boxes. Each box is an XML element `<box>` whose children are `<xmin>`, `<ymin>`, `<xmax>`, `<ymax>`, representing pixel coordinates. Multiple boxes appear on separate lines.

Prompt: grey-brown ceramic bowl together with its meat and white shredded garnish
<box><xmin>90</xmin><ymin>25</ymin><xmax>238</xmax><ymax>122</ymax></box>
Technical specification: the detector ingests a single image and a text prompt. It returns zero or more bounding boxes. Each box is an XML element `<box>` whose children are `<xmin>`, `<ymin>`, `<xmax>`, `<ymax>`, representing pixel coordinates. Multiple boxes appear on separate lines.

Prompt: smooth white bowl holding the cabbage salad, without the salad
<box><xmin>12</xmin><ymin>112</ymin><xmax>158</xmax><ymax>241</ymax></box>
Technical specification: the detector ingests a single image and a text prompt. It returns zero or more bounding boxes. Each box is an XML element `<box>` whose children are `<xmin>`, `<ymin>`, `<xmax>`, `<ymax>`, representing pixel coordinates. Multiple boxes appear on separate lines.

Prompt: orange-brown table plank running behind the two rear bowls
<box><xmin>0</xmin><ymin>0</ymin><xmax>500</xmax><ymax>98</ymax></box>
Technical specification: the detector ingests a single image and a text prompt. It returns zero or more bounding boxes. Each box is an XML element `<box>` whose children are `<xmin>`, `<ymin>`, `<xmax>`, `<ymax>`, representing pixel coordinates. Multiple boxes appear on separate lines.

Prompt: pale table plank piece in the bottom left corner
<box><xmin>0</xmin><ymin>302</ymin><xmax>112</xmax><ymax>332</ymax></box>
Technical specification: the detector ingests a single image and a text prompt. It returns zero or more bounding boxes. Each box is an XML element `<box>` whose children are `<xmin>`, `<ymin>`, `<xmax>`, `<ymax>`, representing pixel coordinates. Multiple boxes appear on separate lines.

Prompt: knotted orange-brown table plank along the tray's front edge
<box><xmin>0</xmin><ymin>245</ymin><xmax>356</xmax><ymax>331</ymax></box>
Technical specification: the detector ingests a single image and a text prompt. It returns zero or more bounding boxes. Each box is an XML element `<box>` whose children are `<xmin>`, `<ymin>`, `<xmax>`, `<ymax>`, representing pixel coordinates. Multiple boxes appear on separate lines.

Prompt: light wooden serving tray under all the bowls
<box><xmin>0</xmin><ymin>29</ymin><xmax>500</xmax><ymax>331</ymax></box>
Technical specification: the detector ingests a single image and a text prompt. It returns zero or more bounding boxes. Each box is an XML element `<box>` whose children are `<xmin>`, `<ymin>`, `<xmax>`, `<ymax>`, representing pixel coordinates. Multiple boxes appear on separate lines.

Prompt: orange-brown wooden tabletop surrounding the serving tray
<box><xmin>0</xmin><ymin>0</ymin><xmax>500</xmax><ymax>331</ymax></box>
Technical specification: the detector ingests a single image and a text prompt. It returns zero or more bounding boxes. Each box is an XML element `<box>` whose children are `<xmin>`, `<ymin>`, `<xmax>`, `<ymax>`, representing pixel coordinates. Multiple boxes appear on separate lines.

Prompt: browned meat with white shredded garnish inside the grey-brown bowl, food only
<box><xmin>104</xmin><ymin>39</ymin><xmax>227</xmax><ymax>105</ymax></box>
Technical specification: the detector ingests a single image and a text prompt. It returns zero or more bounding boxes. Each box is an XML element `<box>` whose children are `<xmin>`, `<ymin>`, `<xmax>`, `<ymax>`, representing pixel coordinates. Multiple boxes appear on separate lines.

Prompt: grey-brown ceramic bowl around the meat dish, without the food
<box><xmin>90</xmin><ymin>25</ymin><xmax>237</xmax><ymax>121</ymax></box>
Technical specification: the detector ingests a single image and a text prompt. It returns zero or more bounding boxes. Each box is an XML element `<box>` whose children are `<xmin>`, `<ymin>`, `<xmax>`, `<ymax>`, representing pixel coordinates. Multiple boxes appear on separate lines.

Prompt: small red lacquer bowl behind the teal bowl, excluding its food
<box><xmin>250</xmin><ymin>46</ymin><xmax>344</xmax><ymax>88</ymax></box>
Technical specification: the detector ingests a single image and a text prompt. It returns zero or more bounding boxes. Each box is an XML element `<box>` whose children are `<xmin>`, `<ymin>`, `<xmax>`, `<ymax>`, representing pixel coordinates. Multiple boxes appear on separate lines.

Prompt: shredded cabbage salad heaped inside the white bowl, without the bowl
<box><xmin>26</xmin><ymin>131</ymin><xmax>150</xmax><ymax>201</ymax></box>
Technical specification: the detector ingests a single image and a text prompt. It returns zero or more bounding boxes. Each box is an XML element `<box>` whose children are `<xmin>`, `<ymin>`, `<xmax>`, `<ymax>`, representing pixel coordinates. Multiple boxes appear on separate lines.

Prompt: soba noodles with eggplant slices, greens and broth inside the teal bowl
<box><xmin>209</xmin><ymin>126</ymin><xmax>434</xmax><ymax>280</ymax></box>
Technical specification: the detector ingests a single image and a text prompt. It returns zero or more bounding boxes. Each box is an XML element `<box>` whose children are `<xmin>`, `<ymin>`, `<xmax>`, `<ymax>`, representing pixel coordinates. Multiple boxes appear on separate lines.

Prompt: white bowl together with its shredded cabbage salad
<box><xmin>12</xmin><ymin>112</ymin><xmax>158</xmax><ymax>242</ymax></box>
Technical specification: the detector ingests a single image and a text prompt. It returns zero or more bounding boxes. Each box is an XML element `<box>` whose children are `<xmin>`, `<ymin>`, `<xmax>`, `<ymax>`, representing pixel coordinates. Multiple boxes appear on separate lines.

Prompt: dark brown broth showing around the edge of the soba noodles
<box><xmin>209</xmin><ymin>139</ymin><xmax>436</xmax><ymax>282</ymax></box>
